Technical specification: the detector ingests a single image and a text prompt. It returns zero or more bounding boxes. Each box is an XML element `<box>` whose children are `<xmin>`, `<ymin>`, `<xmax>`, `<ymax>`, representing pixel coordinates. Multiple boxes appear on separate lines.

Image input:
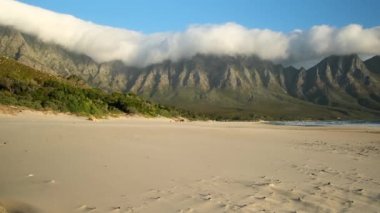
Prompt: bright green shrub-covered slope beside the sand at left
<box><xmin>0</xmin><ymin>57</ymin><xmax>196</xmax><ymax>118</ymax></box>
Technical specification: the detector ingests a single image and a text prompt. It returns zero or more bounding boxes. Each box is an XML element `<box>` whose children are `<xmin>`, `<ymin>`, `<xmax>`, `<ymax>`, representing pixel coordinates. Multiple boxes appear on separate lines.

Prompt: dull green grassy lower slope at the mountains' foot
<box><xmin>148</xmin><ymin>86</ymin><xmax>380</xmax><ymax>120</ymax></box>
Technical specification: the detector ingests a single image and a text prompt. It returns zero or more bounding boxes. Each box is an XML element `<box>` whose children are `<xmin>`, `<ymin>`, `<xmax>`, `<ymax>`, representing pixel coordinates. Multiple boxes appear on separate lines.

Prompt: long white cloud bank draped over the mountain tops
<box><xmin>0</xmin><ymin>0</ymin><xmax>380</xmax><ymax>66</ymax></box>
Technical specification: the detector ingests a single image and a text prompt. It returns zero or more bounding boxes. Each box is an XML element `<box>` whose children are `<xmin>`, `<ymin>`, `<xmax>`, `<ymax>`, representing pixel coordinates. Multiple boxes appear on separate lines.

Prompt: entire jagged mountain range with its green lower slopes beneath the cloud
<box><xmin>0</xmin><ymin>26</ymin><xmax>380</xmax><ymax>120</ymax></box>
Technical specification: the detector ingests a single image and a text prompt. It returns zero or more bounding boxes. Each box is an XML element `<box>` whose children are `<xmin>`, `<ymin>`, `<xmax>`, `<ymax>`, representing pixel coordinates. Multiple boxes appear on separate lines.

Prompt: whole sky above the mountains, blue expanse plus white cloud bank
<box><xmin>0</xmin><ymin>0</ymin><xmax>380</xmax><ymax>66</ymax></box>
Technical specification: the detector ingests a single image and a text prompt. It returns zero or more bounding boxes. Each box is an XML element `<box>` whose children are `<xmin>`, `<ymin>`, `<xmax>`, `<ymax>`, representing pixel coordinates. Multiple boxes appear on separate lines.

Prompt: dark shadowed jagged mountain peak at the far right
<box><xmin>295</xmin><ymin>55</ymin><xmax>380</xmax><ymax>110</ymax></box>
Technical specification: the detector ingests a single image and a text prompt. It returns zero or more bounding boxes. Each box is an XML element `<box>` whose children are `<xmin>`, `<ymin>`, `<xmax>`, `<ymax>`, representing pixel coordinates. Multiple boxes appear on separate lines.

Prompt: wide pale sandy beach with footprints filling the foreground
<box><xmin>0</xmin><ymin>111</ymin><xmax>380</xmax><ymax>213</ymax></box>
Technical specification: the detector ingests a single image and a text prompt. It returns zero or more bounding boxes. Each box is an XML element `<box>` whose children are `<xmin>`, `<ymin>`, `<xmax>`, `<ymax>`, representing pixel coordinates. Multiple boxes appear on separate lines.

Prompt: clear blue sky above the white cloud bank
<box><xmin>17</xmin><ymin>0</ymin><xmax>380</xmax><ymax>33</ymax></box>
